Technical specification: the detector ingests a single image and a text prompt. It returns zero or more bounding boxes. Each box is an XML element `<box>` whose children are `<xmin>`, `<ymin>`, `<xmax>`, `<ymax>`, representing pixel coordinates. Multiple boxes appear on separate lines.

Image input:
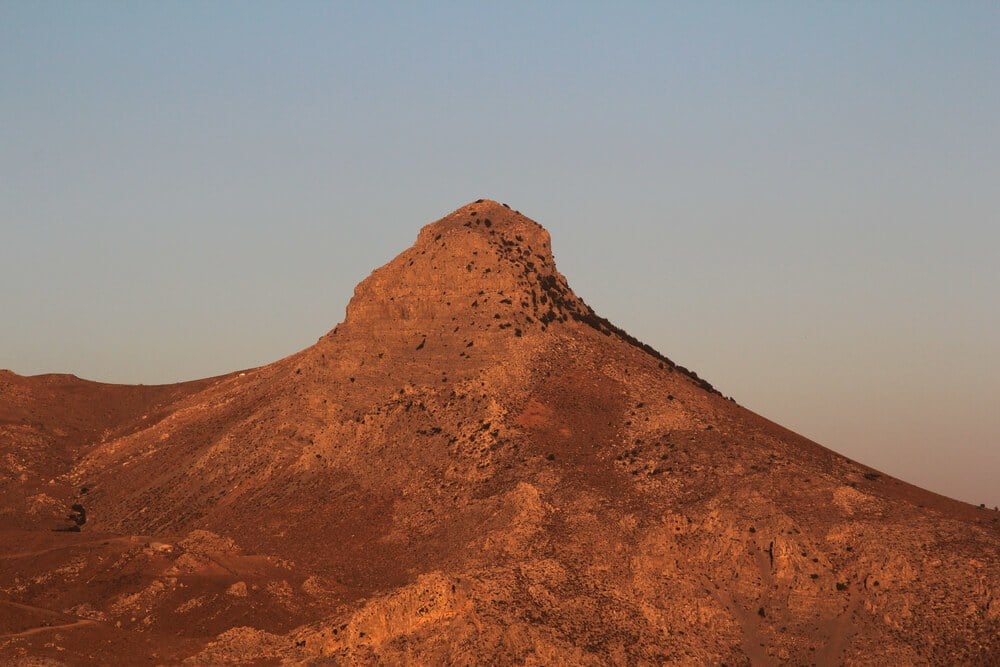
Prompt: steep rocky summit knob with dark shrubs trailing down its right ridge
<box><xmin>330</xmin><ymin>199</ymin><xmax>718</xmax><ymax>393</ymax></box>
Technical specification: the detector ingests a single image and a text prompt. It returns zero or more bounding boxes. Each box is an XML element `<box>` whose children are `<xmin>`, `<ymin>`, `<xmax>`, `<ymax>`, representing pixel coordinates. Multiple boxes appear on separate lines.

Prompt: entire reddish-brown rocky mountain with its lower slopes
<box><xmin>0</xmin><ymin>200</ymin><xmax>1000</xmax><ymax>665</ymax></box>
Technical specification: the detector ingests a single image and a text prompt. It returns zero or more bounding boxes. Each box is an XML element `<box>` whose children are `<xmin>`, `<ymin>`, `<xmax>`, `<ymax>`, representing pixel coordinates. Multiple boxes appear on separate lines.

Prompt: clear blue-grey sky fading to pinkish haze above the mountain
<box><xmin>0</xmin><ymin>1</ymin><xmax>1000</xmax><ymax>507</ymax></box>
